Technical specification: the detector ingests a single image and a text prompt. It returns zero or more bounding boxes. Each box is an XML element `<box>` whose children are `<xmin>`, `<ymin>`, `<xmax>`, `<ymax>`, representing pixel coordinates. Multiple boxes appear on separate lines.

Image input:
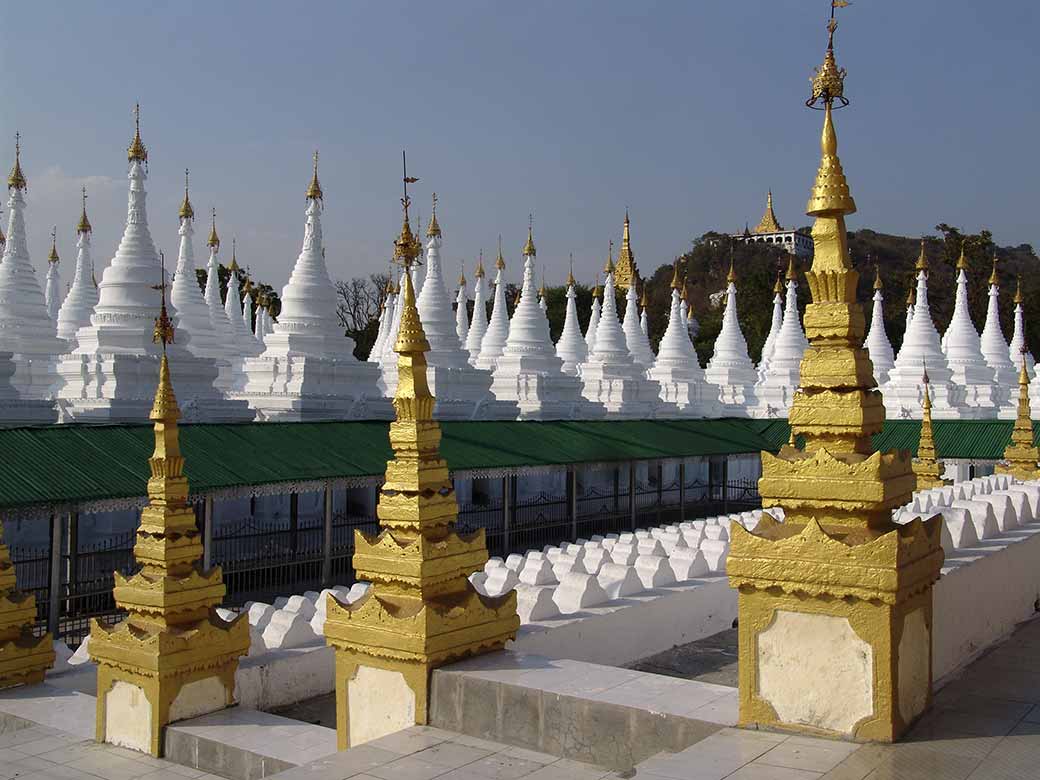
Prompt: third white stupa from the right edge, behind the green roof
<box><xmin>942</xmin><ymin>245</ymin><xmax>1003</xmax><ymax>417</ymax></box>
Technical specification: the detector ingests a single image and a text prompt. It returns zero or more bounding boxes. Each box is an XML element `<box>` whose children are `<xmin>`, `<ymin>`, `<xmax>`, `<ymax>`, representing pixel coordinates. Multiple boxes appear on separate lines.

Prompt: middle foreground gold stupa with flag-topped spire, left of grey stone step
<box><xmin>324</xmin><ymin>185</ymin><xmax>520</xmax><ymax>749</ymax></box>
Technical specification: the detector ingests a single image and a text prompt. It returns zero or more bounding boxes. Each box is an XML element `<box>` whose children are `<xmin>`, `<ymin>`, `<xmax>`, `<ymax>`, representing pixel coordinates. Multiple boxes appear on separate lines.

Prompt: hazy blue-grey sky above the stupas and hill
<box><xmin>0</xmin><ymin>0</ymin><xmax>1040</xmax><ymax>287</ymax></box>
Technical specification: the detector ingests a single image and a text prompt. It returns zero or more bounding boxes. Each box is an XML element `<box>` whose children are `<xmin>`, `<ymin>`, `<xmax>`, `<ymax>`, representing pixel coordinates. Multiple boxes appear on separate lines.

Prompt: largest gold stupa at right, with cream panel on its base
<box><xmin>727</xmin><ymin>13</ymin><xmax>943</xmax><ymax>742</ymax></box>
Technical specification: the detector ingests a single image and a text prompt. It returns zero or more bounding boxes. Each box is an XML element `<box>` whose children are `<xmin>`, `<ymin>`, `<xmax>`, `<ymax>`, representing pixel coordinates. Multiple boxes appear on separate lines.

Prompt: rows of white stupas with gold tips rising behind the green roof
<box><xmin>0</xmin><ymin>112</ymin><xmax>1040</xmax><ymax>425</ymax></box>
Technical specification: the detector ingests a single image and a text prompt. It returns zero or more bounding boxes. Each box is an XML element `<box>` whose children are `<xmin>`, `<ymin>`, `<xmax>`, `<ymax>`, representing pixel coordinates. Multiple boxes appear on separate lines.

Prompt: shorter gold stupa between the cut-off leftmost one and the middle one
<box><xmin>89</xmin><ymin>274</ymin><xmax>250</xmax><ymax>756</ymax></box>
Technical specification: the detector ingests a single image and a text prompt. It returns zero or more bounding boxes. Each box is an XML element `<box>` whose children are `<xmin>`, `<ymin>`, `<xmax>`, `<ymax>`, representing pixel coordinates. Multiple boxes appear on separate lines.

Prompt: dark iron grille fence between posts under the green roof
<box><xmin>10</xmin><ymin>469</ymin><xmax>760</xmax><ymax>647</ymax></box>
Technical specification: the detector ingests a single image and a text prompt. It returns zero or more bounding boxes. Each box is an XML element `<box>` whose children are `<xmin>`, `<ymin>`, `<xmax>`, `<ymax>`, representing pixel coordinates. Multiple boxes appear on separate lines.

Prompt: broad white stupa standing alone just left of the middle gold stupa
<box><xmin>243</xmin><ymin>152</ymin><xmax>393</xmax><ymax>421</ymax></box>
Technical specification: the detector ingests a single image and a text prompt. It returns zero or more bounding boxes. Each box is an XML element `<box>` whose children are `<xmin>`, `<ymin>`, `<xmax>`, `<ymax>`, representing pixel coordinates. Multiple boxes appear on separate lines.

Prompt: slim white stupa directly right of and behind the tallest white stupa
<box><xmin>170</xmin><ymin>170</ymin><xmax>234</xmax><ymax>392</ymax></box>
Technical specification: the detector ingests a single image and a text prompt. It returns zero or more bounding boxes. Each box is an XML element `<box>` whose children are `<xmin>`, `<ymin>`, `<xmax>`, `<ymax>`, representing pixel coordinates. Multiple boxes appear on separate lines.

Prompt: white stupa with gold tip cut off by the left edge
<box><xmin>0</xmin><ymin>140</ymin><xmax>68</xmax><ymax>399</ymax></box>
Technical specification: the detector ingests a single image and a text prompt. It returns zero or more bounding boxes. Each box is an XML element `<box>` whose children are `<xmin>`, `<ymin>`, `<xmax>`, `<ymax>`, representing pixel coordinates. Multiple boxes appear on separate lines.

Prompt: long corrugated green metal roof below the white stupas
<box><xmin>0</xmin><ymin>419</ymin><xmax>1031</xmax><ymax>510</ymax></box>
